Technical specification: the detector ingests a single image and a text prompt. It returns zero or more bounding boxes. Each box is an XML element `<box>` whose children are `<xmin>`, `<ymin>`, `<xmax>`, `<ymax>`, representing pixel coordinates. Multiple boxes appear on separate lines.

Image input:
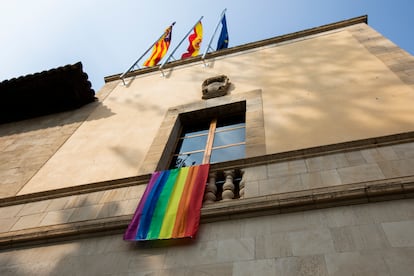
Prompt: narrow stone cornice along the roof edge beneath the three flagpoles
<box><xmin>104</xmin><ymin>15</ymin><xmax>368</xmax><ymax>83</ymax></box>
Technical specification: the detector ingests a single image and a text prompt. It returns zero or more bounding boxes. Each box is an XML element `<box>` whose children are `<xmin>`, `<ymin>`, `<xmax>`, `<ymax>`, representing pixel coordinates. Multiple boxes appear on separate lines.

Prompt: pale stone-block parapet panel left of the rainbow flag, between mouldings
<box><xmin>0</xmin><ymin>185</ymin><xmax>145</xmax><ymax>236</ymax></box>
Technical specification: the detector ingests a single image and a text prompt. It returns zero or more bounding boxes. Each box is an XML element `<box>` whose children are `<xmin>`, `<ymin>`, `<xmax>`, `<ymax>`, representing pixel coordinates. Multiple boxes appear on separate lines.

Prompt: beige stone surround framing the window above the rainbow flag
<box><xmin>138</xmin><ymin>89</ymin><xmax>266</xmax><ymax>174</ymax></box>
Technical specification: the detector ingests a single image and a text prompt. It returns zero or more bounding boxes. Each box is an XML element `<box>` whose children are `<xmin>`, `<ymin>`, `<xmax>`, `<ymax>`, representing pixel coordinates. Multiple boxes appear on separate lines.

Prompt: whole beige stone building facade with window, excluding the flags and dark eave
<box><xmin>0</xmin><ymin>16</ymin><xmax>414</xmax><ymax>275</ymax></box>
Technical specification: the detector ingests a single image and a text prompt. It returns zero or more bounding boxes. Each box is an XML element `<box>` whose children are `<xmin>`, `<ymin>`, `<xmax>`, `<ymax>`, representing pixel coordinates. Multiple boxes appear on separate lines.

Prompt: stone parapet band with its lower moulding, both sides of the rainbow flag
<box><xmin>0</xmin><ymin>138</ymin><xmax>414</xmax><ymax>252</ymax></box>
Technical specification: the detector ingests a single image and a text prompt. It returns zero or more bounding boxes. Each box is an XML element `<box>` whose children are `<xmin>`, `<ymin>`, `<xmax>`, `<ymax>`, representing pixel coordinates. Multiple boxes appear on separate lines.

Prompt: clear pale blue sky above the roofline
<box><xmin>0</xmin><ymin>0</ymin><xmax>414</xmax><ymax>92</ymax></box>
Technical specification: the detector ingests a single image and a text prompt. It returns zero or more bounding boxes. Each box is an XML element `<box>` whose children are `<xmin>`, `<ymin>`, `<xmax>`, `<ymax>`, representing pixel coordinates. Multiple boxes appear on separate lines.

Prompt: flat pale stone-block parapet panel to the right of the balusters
<box><xmin>244</xmin><ymin>143</ymin><xmax>414</xmax><ymax>198</ymax></box>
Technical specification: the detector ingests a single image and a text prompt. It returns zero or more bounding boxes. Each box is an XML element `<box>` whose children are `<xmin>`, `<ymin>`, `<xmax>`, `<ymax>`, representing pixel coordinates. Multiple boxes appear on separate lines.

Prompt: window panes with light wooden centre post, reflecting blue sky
<box><xmin>170</xmin><ymin>113</ymin><xmax>246</xmax><ymax>168</ymax></box>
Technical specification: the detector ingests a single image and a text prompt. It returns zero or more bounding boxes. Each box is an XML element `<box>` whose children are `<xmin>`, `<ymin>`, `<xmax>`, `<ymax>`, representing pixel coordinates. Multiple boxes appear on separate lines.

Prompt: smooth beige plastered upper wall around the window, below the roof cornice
<box><xmin>5</xmin><ymin>24</ymin><xmax>414</xmax><ymax>194</ymax></box>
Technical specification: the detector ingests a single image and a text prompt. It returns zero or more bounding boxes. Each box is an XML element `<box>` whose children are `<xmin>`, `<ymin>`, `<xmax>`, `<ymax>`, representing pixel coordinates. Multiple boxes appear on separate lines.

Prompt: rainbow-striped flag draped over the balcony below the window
<box><xmin>124</xmin><ymin>164</ymin><xmax>210</xmax><ymax>241</ymax></box>
